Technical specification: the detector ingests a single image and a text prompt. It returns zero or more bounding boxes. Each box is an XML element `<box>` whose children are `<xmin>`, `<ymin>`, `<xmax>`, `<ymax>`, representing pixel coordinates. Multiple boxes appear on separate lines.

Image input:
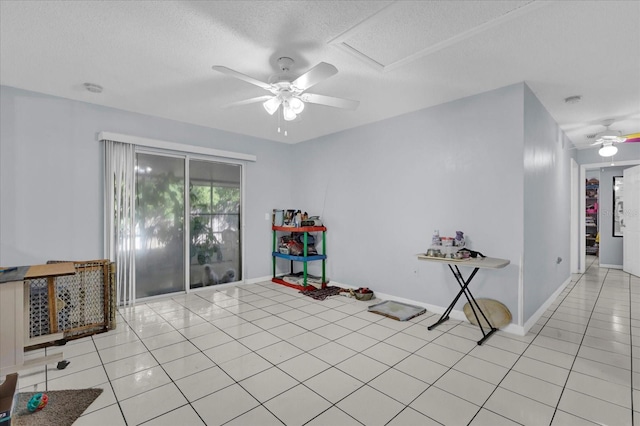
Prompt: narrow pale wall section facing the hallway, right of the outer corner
<box><xmin>523</xmin><ymin>86</ymin><xmax>575</xmax><ymax>322</ymax></box>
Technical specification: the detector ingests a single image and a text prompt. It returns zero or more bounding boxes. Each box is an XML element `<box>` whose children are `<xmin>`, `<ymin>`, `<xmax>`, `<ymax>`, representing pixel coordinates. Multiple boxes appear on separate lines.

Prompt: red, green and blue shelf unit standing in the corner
<box><xmin>271</xmin><ymin>225</ymin><xmax>327</xmax><ymax>290</ymax></box>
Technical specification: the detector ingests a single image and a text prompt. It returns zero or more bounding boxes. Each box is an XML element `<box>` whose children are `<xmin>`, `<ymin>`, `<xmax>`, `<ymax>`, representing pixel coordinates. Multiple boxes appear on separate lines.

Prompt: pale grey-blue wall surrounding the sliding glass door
<box><xmin>0</xmin><ymin>86</ymin><xmax>291</xmax><ymax>278</ymax></box>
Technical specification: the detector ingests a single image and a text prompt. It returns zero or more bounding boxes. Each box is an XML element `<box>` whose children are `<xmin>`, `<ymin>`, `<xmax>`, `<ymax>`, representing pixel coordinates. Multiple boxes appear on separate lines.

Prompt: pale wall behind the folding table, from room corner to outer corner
<box><xmin>293</xmin><ymin>84</ymin><xmax>523</xmax><ymax>318</ymax></box>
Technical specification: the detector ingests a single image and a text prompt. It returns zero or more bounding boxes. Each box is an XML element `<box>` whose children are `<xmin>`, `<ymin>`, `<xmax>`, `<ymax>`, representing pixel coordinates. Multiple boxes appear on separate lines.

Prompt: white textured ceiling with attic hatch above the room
<box><xmin>0</xmin><ymin>0</ymin><xmax>640</xmax><ymax>147</ymax></box>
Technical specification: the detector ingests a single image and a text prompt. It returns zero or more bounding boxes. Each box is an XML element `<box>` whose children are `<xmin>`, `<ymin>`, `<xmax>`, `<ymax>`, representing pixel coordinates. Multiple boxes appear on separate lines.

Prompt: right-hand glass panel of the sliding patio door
<box><xmin>189</xmin><ymin>160</ymin><xmax>241</xmax><ymax>288</ymax></box>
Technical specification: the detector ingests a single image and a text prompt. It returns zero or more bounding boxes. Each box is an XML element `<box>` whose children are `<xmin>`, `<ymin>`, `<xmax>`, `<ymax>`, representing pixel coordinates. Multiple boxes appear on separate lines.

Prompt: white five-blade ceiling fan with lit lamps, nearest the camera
<box><xmin>212</xmin><ymin>56</ymin><xmax>360</xmax><ymax>121</ymax></box>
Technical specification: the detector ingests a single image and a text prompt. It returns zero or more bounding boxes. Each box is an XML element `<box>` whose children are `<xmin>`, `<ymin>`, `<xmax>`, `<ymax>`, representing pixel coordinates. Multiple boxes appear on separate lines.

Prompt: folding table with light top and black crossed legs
<box><xmin>418</xmin><ymin>254</ymin><xmax>510</xmax><ymax>345</ymax></box>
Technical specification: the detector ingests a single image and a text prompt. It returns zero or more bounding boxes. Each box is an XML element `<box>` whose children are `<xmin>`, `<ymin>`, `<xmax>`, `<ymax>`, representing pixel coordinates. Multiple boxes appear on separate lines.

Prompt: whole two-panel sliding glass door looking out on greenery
<box><xmin>135</xmin><ymin>152</ymin><xmax>242</xmax><ymax>298</ymax></box>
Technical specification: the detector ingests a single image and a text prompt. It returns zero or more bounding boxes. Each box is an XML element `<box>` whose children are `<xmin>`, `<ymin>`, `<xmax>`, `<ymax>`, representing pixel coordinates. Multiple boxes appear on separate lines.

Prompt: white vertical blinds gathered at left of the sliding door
<box><xmin>103</xmin><ymin>140</ymin><xmax>136</xmax><ymax>306</ymax></box>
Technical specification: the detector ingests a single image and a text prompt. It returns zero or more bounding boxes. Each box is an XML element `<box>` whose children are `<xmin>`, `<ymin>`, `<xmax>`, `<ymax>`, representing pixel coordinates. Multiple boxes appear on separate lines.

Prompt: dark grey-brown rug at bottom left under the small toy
<box><xmin>11</xmin><ymin>388</ymin><xmax>102</xmax><ymax>426</ymax></box>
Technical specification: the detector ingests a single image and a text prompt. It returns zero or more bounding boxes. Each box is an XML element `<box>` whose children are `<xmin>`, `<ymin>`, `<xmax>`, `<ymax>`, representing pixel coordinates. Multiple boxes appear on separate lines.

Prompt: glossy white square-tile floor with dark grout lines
<box><xmin>12</xmin><ymin>258</ymin><xmax>640</xmax><ymax>426</ymax></box>
